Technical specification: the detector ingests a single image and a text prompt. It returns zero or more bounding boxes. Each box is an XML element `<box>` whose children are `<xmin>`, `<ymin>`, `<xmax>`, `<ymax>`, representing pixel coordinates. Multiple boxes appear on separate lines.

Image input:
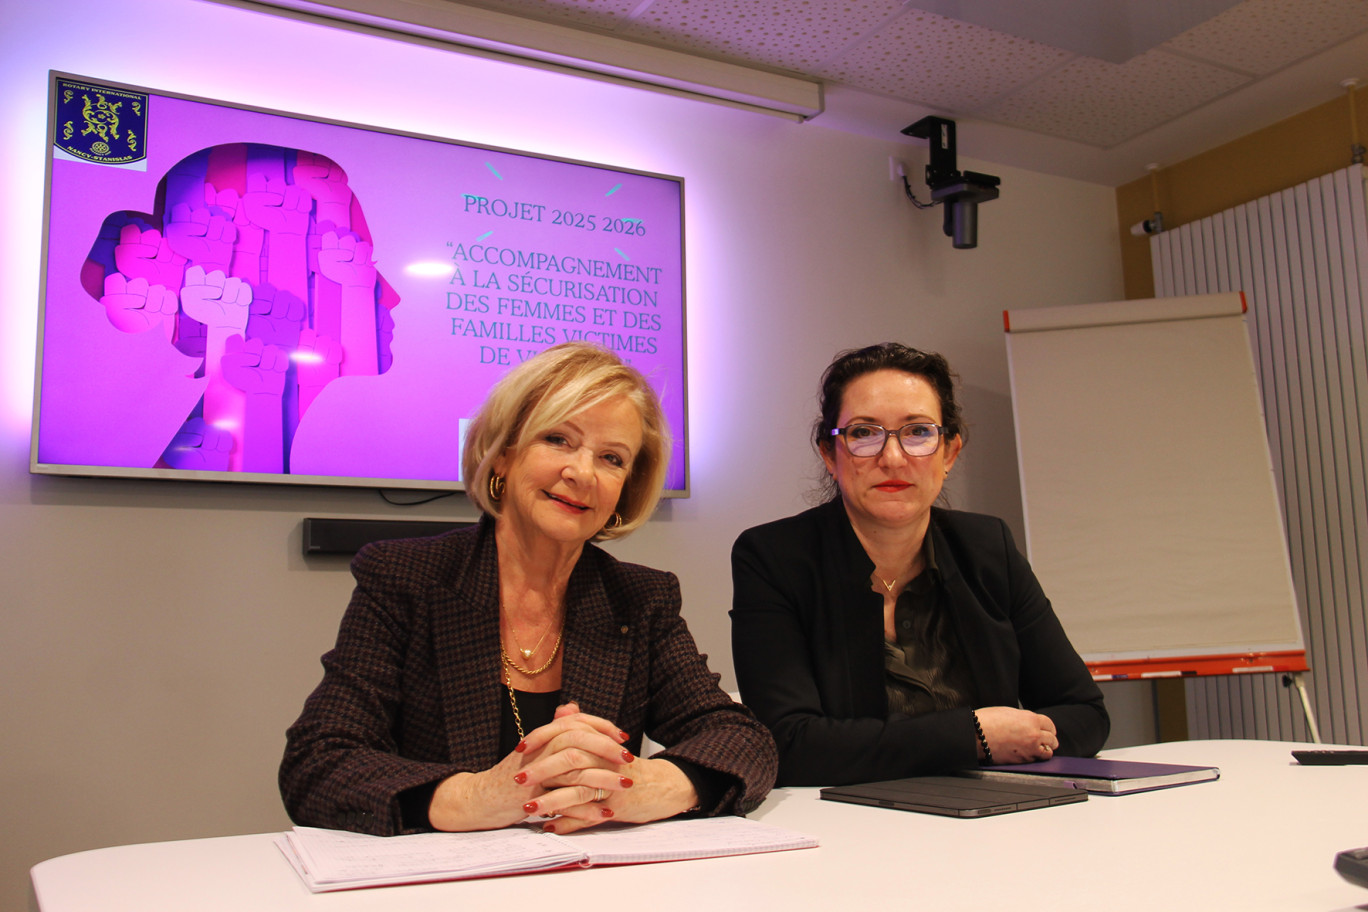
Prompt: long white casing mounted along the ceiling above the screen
<box><xmin>207</xmin><ymin>0</ymin><xmax>822</xmax><ymax>120</ymax></box>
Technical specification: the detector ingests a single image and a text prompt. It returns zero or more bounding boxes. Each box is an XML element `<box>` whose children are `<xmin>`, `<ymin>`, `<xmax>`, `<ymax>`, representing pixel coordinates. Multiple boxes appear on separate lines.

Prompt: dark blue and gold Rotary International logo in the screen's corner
<box><xmin>52</xmin><ymin>79</ymin><xmax>148</xmax><ymax>165</ymax></box>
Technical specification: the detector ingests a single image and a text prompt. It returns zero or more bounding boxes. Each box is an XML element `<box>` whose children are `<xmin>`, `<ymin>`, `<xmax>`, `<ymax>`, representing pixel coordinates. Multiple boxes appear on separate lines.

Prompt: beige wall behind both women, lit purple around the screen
<box><xmin>0</xmin><ymin>0</ymin><xmax>1127</xmax><ymax>908</ymax></box>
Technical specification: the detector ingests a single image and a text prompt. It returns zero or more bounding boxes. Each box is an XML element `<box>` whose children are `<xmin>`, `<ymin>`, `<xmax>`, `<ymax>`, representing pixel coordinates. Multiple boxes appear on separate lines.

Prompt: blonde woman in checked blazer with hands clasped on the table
<box><xmin>279</xmin><ymin>342</ymin><xmax>776</xmax><ymax>835</ymax></box>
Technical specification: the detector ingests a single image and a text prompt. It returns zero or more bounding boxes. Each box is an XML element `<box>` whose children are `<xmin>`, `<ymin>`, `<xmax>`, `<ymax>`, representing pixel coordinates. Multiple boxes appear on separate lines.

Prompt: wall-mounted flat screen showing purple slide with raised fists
<box><xmin>30</xmin><ymin>72</ymin><xmax>688</xmax><ymax>495</ymax></box>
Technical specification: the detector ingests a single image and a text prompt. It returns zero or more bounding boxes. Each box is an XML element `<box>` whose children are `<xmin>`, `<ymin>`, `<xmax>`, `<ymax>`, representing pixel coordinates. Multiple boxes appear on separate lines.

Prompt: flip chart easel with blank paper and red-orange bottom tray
<box><xmin>1003</xmin><ymin>293</ymin><xmax>1319</xmax><ymax>741</ymax></box>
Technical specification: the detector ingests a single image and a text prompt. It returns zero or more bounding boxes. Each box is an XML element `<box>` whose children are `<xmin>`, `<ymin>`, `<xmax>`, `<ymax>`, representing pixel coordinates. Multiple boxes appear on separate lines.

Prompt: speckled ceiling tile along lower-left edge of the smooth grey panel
<box><xmin>818</xmin><ymin>10</ymin><xmax>1074</xmax><ymax>112</ymax></box>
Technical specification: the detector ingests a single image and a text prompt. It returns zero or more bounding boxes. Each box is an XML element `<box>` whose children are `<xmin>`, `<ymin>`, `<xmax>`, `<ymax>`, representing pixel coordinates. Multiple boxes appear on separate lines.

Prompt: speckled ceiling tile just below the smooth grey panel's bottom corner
<box><xmin>977</xmin><ymin>51</ymin><xmax>1249</xmax><ymax>149</ymax></box>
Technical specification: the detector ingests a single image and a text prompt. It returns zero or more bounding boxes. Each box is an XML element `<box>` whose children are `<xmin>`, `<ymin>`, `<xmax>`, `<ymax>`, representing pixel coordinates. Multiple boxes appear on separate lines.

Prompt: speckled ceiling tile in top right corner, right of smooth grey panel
<box><xmin>1164</xmin><ymin>0</ymin><xmax>1368</xmax><ymax>77</ymax></box>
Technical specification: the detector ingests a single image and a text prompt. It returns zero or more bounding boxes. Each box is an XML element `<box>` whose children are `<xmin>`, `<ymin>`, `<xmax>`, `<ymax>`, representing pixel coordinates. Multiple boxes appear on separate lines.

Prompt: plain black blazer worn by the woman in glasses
<box><xmin>732</xmin><ymin>498</ymin><xmax>1109</xmax><ymax>785</ymax></box>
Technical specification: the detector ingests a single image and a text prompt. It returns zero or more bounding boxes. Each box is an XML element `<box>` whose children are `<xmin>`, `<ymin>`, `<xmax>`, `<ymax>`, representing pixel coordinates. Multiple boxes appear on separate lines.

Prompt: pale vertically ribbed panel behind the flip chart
<box><xmin>1150</xmin><ymin>165</ymin><xmax>1368</xmax><ymax>744</ymax></box>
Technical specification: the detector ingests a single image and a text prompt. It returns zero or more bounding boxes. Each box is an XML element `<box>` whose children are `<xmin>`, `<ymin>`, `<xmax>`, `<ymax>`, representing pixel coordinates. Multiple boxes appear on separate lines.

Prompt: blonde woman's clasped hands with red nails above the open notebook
<box><xmin>428</xmin><ymin>703</ymin><xmax>698</xmax><ymax>834</ymax></box>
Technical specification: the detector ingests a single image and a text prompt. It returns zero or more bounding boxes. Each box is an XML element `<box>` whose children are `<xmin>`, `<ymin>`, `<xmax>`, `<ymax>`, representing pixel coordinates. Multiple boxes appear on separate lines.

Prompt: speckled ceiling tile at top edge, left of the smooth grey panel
<box><xmin>621</xmin><ymin>0</ymin><xmax>903</xmax><ymax>70</ymax></box>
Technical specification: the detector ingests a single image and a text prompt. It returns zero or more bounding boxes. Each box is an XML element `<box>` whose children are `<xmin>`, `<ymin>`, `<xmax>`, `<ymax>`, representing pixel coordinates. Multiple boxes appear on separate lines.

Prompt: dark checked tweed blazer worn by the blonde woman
<box><xmin>279</xmin><ymin>517</ymin><xmax>777</xmax><ymax>835</ymax></box>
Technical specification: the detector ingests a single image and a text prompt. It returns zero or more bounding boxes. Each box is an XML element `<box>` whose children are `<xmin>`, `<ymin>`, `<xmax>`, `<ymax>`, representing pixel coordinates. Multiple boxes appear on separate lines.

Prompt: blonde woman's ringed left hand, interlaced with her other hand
<box><xmin>528</xmin><ymin>703</ymin><xmax>698</xmax><ymax>834</ymax></box>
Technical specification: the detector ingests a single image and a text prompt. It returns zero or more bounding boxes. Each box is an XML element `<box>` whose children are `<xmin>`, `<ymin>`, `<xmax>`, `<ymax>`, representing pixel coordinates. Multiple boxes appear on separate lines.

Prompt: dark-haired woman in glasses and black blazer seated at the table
<box><xmin>732</xmin><ymin>342</ymin><xmax>1109</xmax><ymax>785</ymax></box>
